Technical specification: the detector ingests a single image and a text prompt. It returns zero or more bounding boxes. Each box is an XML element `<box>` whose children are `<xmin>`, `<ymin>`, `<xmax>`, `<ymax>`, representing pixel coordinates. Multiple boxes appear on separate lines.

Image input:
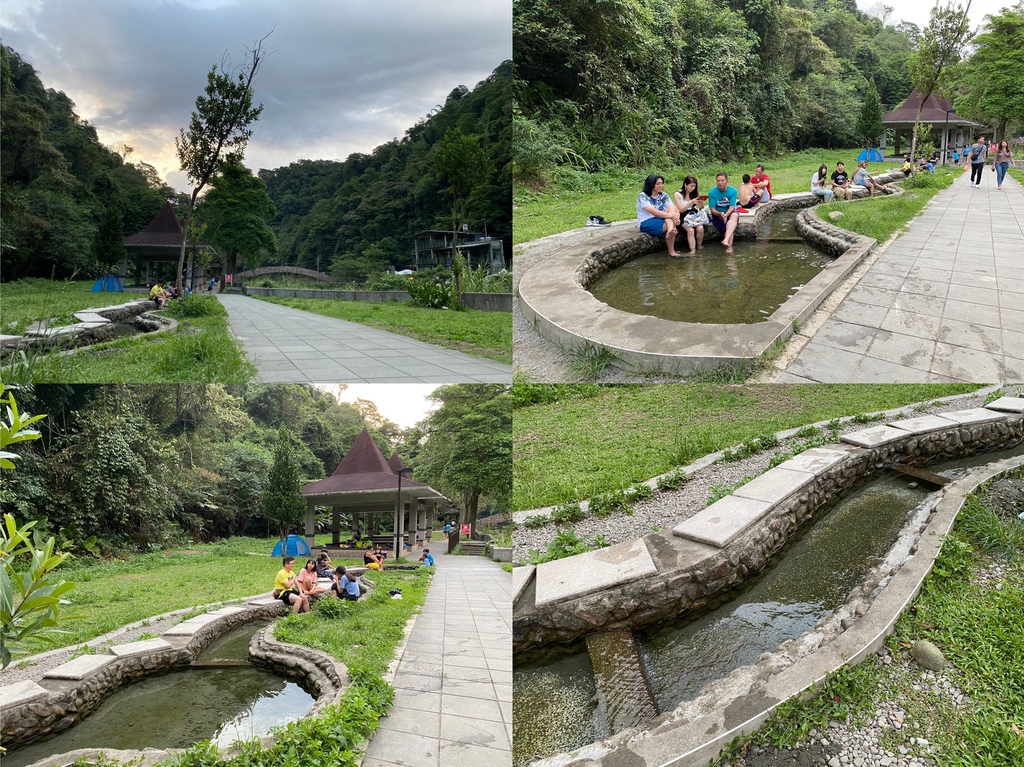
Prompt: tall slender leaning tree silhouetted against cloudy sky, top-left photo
<box><xmin>174</xmin><ymin>36</ymin><xmax>268</xmax><ymax>295</ymax></box>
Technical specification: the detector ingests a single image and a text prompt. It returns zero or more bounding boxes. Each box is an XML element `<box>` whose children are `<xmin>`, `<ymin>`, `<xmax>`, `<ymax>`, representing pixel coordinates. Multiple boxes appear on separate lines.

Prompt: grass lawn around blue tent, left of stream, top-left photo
<box><xmin>0</xmin><ymin>279</ymin><xmax>145</xmax><ymax>335</ymax></box>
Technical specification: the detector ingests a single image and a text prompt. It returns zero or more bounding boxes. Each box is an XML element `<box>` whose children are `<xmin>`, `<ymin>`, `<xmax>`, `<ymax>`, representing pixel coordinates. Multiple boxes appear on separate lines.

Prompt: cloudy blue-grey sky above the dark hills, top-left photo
<box><xmin>0</xmin><ymin>0</ymin><xmax>512</xmax><ymax>190</ymax></box>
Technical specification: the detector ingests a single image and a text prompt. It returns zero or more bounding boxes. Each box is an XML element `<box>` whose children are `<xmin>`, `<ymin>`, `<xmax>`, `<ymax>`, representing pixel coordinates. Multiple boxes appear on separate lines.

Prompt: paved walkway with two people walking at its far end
<box><xmin>778</xmin><ymin>167</ymin><xmax>1024</xmax><ymax>383</ymax></box>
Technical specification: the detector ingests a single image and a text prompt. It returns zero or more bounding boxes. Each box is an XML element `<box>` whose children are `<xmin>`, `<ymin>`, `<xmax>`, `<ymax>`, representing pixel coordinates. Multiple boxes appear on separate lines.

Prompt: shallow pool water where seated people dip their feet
<box><xmin>589</xmin><ymin>211</ymin><xmax>833</xmax><ymax>324</ymax></box>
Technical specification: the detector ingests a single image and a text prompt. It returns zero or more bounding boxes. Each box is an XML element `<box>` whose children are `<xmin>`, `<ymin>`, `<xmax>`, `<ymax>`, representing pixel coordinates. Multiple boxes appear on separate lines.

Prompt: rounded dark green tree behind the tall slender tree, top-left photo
<box><xmin>196</xmin><ymin>154</ymin><xmax>278</xmax><ymax>287</ymax></box>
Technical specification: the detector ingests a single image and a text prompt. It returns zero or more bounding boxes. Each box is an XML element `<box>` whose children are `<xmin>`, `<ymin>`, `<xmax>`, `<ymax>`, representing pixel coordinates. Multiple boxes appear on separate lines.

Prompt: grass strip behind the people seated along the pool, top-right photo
<box><xmin>513</xmin><ymin>148</ymin><xmax>897</xmax><ymax>244</ymax></box>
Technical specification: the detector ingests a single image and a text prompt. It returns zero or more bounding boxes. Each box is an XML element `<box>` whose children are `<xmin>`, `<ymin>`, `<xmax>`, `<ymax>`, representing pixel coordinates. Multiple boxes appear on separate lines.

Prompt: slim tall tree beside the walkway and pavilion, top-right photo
<box><xmin>907</xmin><ymin>0</ymin><xmax>971</xmax><ymax>162</ymax></box>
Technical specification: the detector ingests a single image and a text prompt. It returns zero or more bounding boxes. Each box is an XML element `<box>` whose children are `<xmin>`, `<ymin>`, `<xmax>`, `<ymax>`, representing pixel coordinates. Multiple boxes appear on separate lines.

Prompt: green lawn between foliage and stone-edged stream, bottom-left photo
<box><xmin>23</xmin><ymin>538</ymin><xmax>362</xmax><ymax>647</ymax></box>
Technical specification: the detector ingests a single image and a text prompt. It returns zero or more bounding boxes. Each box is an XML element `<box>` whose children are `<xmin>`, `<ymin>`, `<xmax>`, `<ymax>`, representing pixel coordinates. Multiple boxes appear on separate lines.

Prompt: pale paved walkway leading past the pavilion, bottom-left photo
<box><xmin>362</xmin><ymin>545</ymin><xmax>512</xmax><ymax>767</ymax></box>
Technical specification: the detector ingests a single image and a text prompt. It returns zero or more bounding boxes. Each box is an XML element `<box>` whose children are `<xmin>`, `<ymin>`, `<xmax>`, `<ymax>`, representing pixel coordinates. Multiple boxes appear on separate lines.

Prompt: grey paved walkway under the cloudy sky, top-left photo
<box><xmin>217</xmin><ymin>294</ymin><xmax>512</xmax><ymax>383</ymax></box>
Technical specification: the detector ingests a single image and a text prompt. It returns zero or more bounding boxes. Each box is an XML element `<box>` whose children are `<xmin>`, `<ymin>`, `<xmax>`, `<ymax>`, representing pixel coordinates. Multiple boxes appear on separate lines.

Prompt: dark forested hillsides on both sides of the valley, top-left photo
<box><xmin>0</xmin><ymin>46</ymin><xmax>512</xmax><ymax>281</ymax></box>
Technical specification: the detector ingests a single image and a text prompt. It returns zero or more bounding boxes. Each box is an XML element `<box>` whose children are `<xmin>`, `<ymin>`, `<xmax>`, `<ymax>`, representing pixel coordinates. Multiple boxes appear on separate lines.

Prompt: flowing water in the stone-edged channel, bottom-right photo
<box><xmin>512</xmin><ymin>445</ymin><xmax>1024</xmax><ymax>766</ymax></box>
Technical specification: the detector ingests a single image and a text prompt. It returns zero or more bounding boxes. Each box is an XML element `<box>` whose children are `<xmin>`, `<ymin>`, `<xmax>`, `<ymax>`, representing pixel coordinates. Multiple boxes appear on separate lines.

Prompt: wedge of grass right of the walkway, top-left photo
<box><xmin>258</xmin><ymin>296</ymin><xmax>512</xmax><ymax>365</ymax></box>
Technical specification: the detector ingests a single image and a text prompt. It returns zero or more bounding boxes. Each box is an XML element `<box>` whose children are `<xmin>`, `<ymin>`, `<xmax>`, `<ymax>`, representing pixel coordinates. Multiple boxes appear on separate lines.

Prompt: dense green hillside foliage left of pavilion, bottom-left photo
<box><xmin>3</xmin><ymin>385</ymin><xmax>376</xmax><ymax>551</ymax></box>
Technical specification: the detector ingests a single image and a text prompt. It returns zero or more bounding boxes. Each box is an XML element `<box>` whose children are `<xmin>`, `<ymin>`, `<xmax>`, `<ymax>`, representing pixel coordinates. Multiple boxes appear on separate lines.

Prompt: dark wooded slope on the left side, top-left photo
<box><xmin>0</xmin><ymin>46</ymin><xmax>174</xmax><ymax>281</ymax></box>
